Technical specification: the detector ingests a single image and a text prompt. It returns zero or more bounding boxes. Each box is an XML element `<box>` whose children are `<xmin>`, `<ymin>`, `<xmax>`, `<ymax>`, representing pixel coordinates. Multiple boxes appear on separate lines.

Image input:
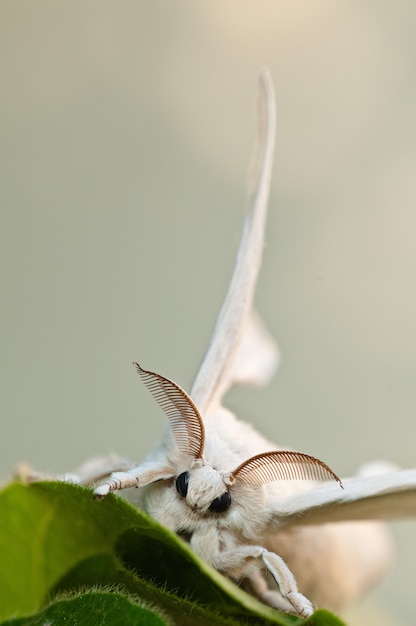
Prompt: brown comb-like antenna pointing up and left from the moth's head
<box><xmin>134</xmin><ymin>363</ymin><xmax>205</xmax><ymax>459</ymax></box>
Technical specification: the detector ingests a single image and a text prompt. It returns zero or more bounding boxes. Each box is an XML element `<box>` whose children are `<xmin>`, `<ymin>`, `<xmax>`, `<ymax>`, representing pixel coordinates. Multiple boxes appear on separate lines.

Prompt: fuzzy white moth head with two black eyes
<box><xmin>175</xmin><ymin>465</ymin><xmax>231</xmax><ymax>513</ymax></box>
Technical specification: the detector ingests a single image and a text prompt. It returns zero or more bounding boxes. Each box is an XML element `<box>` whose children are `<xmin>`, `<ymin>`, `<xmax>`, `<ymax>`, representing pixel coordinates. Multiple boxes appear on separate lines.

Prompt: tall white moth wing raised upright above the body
<box><xmin>190</xmin><ymin>70</ymin><xmax>277</xmax><ymax>417</ymax></box>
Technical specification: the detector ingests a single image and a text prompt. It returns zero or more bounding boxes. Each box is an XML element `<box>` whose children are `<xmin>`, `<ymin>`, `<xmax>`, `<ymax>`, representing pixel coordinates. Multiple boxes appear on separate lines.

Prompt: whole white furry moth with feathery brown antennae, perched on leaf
<box><xmin>31</xmin><ymin>71</ymin><xmax>416</xmax><ymax>616</ymax></box>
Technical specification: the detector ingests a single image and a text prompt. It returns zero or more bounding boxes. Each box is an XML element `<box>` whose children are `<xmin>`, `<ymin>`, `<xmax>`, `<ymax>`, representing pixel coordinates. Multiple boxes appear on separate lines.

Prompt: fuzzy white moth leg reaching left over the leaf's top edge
<box><xmin>94</xmin><ymin>463</ymin><xmax>175</xmax><ymax>499</ymax></box>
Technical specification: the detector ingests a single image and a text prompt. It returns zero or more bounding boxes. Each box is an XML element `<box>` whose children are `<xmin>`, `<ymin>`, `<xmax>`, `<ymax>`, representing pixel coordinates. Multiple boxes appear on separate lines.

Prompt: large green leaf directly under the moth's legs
<box><xmin>0</xmin><ymin>482</ymin><xmax>342</xmax><ymax>626</ymax></box>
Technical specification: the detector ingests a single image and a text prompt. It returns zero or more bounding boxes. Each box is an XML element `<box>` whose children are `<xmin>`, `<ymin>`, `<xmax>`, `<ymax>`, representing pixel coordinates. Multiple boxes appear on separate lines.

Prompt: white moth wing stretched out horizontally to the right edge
<box><xmin>269</xmin><ymin>469</ymin><xmax>416</xmax><ymax>528</ymax></box>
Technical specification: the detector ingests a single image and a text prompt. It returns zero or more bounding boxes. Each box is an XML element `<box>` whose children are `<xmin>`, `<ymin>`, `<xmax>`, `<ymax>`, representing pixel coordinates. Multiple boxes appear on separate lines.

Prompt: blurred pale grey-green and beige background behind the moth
<box><xmin>0</xmin><ymin>0</ymin><xmax>416</xmax><ymax>625</ymax></box>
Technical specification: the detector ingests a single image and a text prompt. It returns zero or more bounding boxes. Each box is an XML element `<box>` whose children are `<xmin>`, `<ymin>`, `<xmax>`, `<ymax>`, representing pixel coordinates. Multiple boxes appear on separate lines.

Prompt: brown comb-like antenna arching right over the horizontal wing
<box><xmin>231</xmin><ymin>450</ymin><xmax>342</xmax><ymax>487</ymax></box>
